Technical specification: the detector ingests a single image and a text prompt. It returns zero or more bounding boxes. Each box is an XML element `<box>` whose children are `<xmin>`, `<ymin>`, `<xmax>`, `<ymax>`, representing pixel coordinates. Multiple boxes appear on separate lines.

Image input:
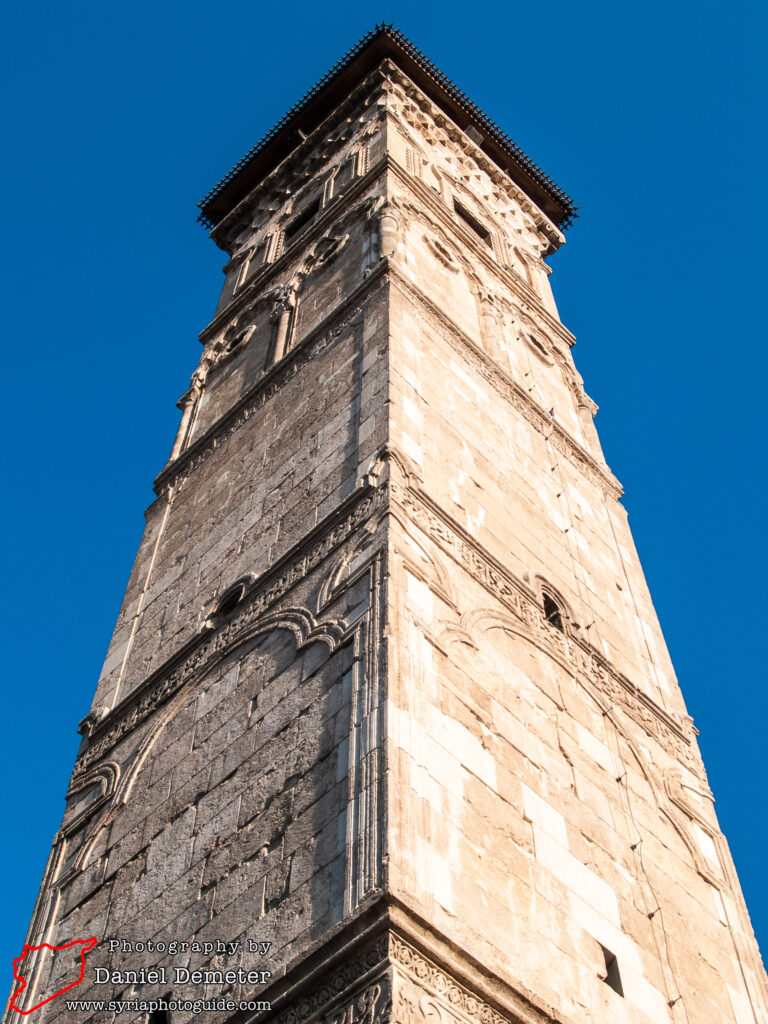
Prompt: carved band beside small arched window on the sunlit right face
<box><xmin>391</xmin><ymin>481</ymin><xmax>703</xmax><ymax>777</ymax></box>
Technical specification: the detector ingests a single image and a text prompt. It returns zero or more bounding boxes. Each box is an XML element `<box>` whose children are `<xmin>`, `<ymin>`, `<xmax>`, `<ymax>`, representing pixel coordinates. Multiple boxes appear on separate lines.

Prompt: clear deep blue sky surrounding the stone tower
<box><xmin>0</xmin><ymin>0</ymin><xmax>768</xmax><ymax>987</ymax></box>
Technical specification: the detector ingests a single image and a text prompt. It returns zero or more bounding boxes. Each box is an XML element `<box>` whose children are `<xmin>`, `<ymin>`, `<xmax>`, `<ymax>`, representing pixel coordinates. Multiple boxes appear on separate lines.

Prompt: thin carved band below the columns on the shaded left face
<box><xmin>155</xmin><ymin>262</ymin><xmax>386</xmax><ymax>495</ymax></box>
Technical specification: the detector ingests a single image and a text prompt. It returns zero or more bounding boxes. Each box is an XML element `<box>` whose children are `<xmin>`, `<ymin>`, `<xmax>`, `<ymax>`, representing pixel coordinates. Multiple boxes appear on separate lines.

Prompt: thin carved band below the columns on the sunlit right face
<box><xmin>390</xmin><ymin>264</ymin><xmax>624</xmax><ymax>501</ymax></box>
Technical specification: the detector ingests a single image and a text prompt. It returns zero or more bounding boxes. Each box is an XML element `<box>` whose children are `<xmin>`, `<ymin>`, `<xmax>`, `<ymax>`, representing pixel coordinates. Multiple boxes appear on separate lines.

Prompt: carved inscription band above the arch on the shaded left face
<box><xmin>73</xmin><ymin>484</ymin><xmax>387</xmax><ymax>785</ymax></box>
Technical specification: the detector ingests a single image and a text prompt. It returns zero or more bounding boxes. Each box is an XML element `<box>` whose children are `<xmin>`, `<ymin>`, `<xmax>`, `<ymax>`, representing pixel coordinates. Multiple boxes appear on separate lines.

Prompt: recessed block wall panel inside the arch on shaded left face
<box><xmin>54</xmin><ymin>609</ymin><xmax>353</xmax><ymax>968</ymax></box>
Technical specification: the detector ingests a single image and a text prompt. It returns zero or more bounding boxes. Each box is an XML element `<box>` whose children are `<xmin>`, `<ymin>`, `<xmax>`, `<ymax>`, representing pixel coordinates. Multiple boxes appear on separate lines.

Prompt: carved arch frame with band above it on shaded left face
<box><xmin>39</xmin><ymin>481</ymin><xmax>388</xmax><ymax>958</ymax></box>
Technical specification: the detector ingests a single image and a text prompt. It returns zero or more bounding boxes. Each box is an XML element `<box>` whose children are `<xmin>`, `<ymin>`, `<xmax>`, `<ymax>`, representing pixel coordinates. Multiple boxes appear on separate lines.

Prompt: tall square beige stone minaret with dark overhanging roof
<box><xmin>6</xmin><ymin>22</ymin><xmax>768</xmax><ymax>1024</ymax></box>
